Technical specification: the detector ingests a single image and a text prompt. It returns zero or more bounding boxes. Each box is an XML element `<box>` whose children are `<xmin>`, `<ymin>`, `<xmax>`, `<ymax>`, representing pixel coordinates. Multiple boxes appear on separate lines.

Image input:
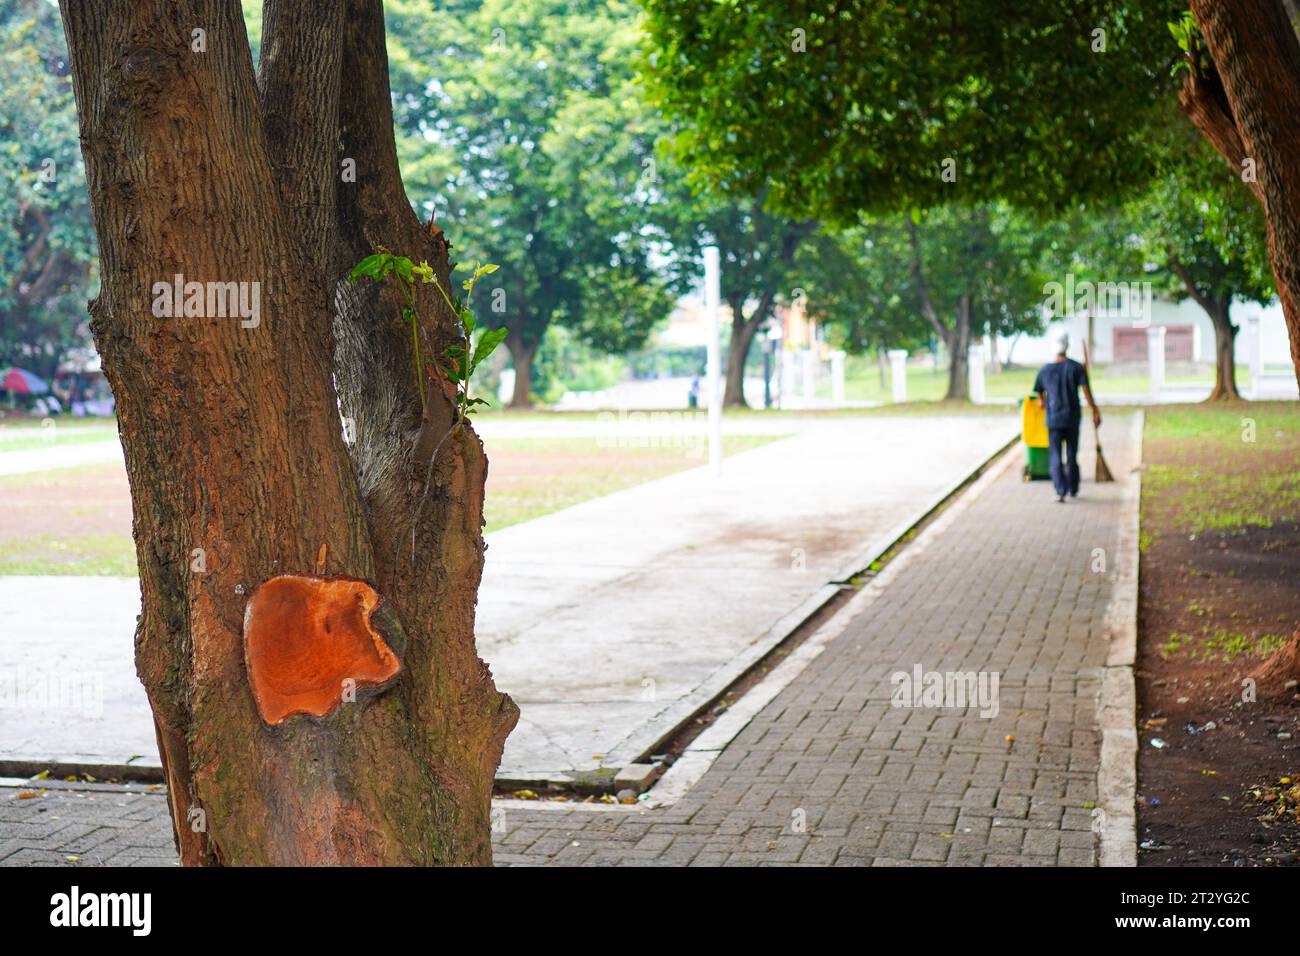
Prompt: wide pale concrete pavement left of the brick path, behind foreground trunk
<box><xmin>0</xmin><ymin>412</ymin><xmax>1017</xmax><ymax>783</ymax></box>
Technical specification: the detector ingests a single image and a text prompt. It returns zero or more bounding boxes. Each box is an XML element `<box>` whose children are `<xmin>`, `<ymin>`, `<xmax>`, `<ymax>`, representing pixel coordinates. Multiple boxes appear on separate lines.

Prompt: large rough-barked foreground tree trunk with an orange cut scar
<box><xmin>61</xmin><ymin>0</ymin><xmax>517</xmax><ymax>865</ymax></box>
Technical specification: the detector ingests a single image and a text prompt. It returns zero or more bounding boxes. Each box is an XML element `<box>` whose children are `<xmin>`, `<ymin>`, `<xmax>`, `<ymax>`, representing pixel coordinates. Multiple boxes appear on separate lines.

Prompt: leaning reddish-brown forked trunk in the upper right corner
<box><xmin>1179</xmin><ymin>0</ymin><xmax>1300</xmax><ymax>381</ymax></box>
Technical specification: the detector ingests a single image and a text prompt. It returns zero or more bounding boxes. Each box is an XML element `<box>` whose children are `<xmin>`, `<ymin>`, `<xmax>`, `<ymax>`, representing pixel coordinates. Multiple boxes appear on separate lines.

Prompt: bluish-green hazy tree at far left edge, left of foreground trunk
<box><xmin>0</xmin><ymin>0</ymin><xmax>95</xmax><ymax>378</ymax></box>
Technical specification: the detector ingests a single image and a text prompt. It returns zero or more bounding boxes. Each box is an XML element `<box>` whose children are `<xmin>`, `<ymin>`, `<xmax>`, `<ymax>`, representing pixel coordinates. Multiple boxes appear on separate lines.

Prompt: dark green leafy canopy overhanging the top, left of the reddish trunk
<box><xmin>646</xmin><ymin>0</ymin><xmax>1179</xmax><ymax>225</ymax></box>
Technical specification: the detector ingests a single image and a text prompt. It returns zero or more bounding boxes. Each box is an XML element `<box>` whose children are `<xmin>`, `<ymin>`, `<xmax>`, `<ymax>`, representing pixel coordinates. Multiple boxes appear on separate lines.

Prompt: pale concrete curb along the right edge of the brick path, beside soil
<box><xmin>1097</xmin><ymin>410</ymin><xmax>1144</xmax><ymax>866</ymax></box>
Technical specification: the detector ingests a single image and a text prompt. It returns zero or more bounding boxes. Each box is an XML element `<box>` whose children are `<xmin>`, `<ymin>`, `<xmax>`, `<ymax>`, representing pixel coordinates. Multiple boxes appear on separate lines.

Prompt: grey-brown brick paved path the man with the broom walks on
<box><xmin>0</xmin><ymin>421</ymin><xmax>1131</xmax><ymax>866</ymax></box>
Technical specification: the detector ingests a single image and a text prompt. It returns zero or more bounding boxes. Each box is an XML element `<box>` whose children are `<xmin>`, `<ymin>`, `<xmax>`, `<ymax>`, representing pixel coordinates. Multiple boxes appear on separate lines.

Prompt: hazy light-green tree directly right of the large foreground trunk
<box><xmin>389</xmin><ymin>0</ymin><xmax>672</xmax><ymax>407</ymax></box>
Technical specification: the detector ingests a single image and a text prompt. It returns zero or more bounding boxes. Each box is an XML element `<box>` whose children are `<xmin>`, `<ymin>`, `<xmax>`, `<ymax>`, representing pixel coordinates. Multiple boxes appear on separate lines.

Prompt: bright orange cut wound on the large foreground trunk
<box><xmin>244</xmin><ymin>575</ymin><xmax>402</xmax><ymax>724</ymax></box>
